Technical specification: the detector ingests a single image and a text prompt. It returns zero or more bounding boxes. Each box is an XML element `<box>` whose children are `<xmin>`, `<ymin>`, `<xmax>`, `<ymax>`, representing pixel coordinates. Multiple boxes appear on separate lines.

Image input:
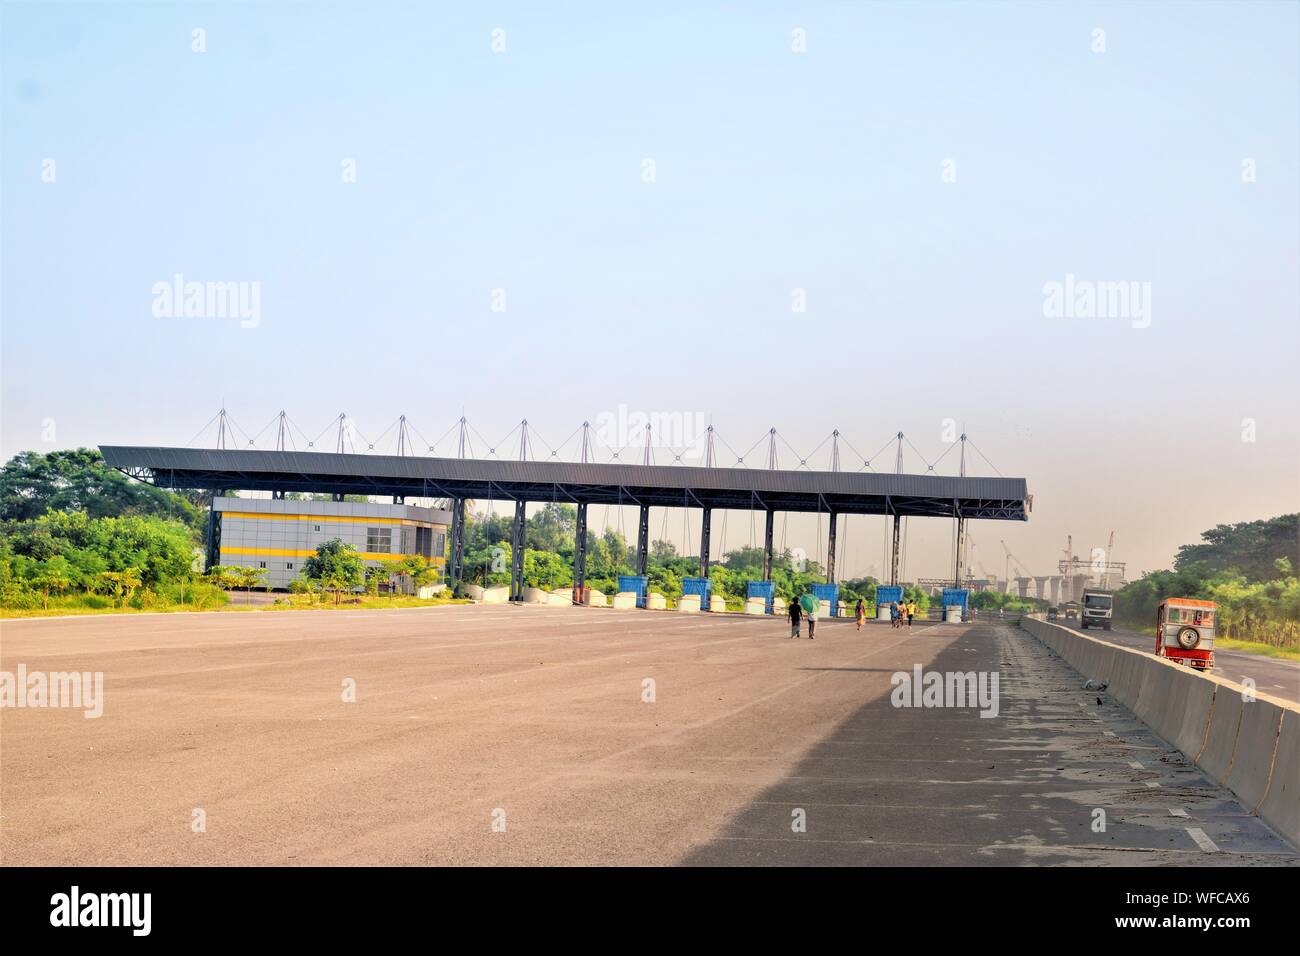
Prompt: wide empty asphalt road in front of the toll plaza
<box><xmin>0</xmin><ymin>606</ymin><xmax>1300</xmax><ymax>866</ymax></box>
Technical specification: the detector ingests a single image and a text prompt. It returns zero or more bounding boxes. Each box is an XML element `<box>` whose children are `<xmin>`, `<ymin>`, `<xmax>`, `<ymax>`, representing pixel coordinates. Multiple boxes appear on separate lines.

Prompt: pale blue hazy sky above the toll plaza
<box><xmin>0</xmin><ymin>1</ymin><xmax>1300</xmax><ymax>575</ymax></box>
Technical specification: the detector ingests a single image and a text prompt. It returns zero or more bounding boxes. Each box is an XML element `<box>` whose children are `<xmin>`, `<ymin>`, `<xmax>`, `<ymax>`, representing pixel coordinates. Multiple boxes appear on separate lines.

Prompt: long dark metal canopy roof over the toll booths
<box><xmin>100</xmin><ymin>445</ymin><xmax>1030</xmax><ymax>522</ymax></box>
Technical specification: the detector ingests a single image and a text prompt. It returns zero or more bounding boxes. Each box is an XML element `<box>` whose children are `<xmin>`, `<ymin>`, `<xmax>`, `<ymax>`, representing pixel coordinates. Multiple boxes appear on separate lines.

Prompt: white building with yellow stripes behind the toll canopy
<box><xmin>212</xmin><ymin>497</ymin><xmax>451</xmax><ymax>591</ymax></box>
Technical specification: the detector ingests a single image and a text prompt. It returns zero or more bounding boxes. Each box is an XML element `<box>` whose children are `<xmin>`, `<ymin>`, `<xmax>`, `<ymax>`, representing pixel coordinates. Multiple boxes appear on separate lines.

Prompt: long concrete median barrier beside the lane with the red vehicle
<box><xmin>1021</xmin><ymin>618</ymin><xmax>1300</xmax><ymax>845</ymax></box>
